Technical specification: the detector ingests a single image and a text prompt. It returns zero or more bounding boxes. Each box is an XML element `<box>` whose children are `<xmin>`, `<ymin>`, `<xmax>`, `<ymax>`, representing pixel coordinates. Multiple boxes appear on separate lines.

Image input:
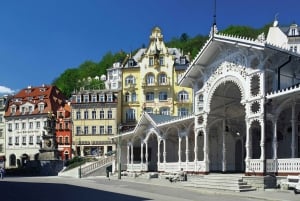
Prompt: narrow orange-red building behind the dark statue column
<box><xmin>56</xmin><ymin>104</ymin><xmax>72</xmax><ymax>160</ymax></box>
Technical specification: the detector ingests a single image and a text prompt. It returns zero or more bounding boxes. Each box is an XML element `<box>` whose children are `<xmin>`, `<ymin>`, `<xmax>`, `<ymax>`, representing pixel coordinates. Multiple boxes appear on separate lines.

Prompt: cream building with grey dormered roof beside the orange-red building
<box><xmin>71</xmin><ymin>88</ymin><xmax>121</xmax><ymax>157</ymax></box>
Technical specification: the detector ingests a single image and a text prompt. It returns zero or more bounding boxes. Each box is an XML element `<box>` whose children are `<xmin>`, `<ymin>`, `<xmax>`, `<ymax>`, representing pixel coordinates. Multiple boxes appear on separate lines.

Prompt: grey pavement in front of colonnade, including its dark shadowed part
<box><xmin>0</xmin><ymin>177</ymin><xmax>300</xmax><ymax>201</ymax></box>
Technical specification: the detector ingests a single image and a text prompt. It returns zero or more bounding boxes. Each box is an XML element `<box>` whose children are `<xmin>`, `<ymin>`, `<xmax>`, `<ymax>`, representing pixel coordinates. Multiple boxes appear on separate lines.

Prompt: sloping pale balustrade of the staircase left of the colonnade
<box><xmin>79</xmin><ymin>156</ymin><xmax>115</xmax><ymax>177</ymax></box>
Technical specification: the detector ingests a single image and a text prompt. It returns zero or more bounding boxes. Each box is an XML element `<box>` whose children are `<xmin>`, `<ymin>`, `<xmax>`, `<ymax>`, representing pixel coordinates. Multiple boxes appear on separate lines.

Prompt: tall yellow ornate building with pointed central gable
<box><xmin>122</xmin><ymin>27</ymin><xmax>193</xmax><ymax>130</ymax></box>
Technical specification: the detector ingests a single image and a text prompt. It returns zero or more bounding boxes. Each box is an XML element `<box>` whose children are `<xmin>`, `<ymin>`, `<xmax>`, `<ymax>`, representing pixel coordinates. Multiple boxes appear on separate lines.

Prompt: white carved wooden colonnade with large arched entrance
<box><xmin>115</xmin><ymin>20</ymin><xmax>300</xmax><ymax>175</ymax></box>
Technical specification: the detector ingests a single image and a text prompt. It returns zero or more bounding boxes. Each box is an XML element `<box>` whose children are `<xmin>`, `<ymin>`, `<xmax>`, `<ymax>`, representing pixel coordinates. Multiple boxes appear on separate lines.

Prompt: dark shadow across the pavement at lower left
<box><xmin>0</xmin><ymin>181</ymin><xmax>149</xmax><ymax>201</ymax></box>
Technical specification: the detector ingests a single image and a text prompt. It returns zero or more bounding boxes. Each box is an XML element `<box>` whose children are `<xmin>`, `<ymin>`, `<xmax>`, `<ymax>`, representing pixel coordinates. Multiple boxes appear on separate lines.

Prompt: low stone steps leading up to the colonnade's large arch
<box><xmin>183</xmin><ymin>174</ymin><xmax>256</xmax><ymax>192</ymax></box>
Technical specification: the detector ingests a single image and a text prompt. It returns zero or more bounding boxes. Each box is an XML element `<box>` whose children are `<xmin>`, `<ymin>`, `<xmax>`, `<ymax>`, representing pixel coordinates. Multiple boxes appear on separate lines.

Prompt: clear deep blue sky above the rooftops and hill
<box><xmin>0</xmin><ymin>0</ymin><xmax>300</xmax><ymax>93</ymax></box>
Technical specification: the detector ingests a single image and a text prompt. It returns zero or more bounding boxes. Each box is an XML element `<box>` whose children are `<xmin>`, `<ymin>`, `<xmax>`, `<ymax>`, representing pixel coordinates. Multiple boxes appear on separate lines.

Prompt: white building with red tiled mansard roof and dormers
<box><xmin>4</xmin><ymin>85</ymin><xmax>66</xmax><ymax>168</ymax></box>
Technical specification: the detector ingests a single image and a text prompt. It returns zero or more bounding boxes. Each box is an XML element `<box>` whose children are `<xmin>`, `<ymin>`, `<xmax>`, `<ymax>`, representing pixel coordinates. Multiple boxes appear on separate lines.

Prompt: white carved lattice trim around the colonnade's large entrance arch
<box><xmin>204</xmin><ymin>75</ymin><xmax>245</xmax><ymax>113</ymax></box>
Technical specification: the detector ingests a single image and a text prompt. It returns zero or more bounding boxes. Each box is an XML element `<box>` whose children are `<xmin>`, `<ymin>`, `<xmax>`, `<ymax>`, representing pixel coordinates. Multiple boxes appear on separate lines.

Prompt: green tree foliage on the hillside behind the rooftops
<box><xmin>52</xmin><ymin>24</ymin><xmax>271</xmax><ymax>97</ymax></box>
